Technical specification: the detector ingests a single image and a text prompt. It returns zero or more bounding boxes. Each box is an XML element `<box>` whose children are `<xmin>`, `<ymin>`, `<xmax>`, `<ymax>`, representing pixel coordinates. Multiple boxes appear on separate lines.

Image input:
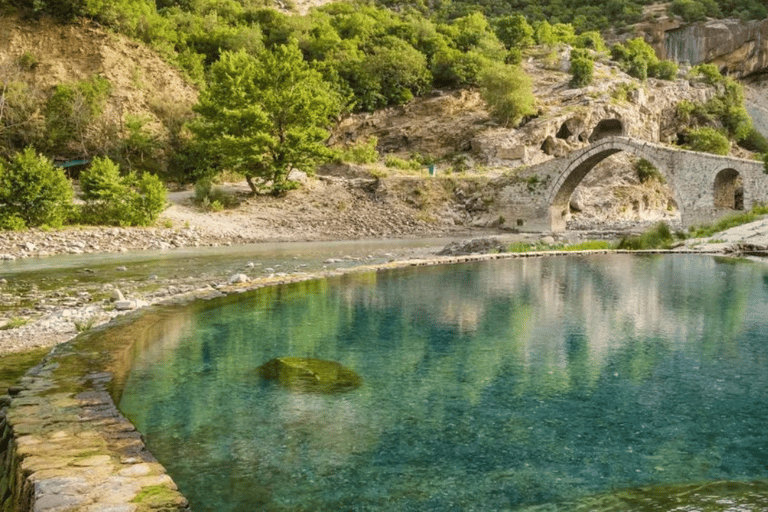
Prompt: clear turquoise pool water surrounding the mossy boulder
<box><xmin>120</xmin><ymin>256</ymin><xmax>768</xmax><ymax>511</ymax></box>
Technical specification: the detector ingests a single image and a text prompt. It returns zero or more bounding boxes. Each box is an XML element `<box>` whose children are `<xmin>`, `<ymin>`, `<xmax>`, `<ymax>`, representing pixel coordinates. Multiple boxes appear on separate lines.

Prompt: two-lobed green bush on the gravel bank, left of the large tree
<box><xmin>80</xmin><ymin>158</ymin><xmax>166</xmax><ymax>226</ymax></box>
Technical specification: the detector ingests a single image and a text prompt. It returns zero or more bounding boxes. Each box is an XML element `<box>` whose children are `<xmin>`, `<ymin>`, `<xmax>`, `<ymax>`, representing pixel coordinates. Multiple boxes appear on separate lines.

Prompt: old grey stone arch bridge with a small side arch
<box><xmin>503</xmin><ymin>136</ymin><xmax>768</xmax><ymax>231</ymax></box>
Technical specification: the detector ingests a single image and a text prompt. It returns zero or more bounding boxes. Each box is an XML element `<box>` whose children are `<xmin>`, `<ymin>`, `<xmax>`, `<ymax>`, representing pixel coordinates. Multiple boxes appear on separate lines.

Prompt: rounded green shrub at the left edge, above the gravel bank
<box><xmin>0</xmin><ymin>148</ymin><xmax>73</xmax><ymax>229</ymax></box>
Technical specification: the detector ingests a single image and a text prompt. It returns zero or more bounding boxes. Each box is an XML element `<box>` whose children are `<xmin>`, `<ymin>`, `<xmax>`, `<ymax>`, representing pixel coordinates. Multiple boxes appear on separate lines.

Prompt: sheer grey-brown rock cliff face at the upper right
<box><xmin>659</xmin><ymin>19</ymin><xmax>768</xmax><ymax>77</ymax></box>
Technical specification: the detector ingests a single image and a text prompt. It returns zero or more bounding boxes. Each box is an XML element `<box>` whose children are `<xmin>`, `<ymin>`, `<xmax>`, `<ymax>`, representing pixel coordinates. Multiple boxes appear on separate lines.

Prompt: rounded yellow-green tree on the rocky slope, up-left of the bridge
<box><xmin>480</xmin><ymin>63</ymin><xmax>536</xmax><ymax>126</ymax></box>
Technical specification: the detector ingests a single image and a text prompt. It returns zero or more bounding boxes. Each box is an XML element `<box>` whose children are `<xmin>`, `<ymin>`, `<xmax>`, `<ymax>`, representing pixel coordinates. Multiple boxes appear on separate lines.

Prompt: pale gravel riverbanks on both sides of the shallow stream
<box><xmin>0</xmin><ymin>180</ymin><xmax>768</xmax><ymax>356</ymax></box>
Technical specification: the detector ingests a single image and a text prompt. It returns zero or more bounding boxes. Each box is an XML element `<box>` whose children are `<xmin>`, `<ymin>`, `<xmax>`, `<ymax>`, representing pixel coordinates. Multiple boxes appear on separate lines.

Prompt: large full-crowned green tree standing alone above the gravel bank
<box><xmin>191</xmin><ymin>43</ymin><xmax>341</xmax><ymax>194</ymax></box>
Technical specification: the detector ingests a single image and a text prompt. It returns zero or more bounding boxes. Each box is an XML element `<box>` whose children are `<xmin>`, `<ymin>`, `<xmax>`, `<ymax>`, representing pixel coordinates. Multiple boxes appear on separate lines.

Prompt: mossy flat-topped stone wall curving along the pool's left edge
<box><xmin>0</xmin><ymin>308</ymin><xmax>188</xmax><ymax>512</ymax></box>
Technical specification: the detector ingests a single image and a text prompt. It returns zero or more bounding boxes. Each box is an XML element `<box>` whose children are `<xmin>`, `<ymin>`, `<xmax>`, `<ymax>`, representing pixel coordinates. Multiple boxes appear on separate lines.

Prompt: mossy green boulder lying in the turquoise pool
<box><xmin>259</xmin><ymin>357</ymin><xmax>363</xmax><ymax>393</ymax></box>
